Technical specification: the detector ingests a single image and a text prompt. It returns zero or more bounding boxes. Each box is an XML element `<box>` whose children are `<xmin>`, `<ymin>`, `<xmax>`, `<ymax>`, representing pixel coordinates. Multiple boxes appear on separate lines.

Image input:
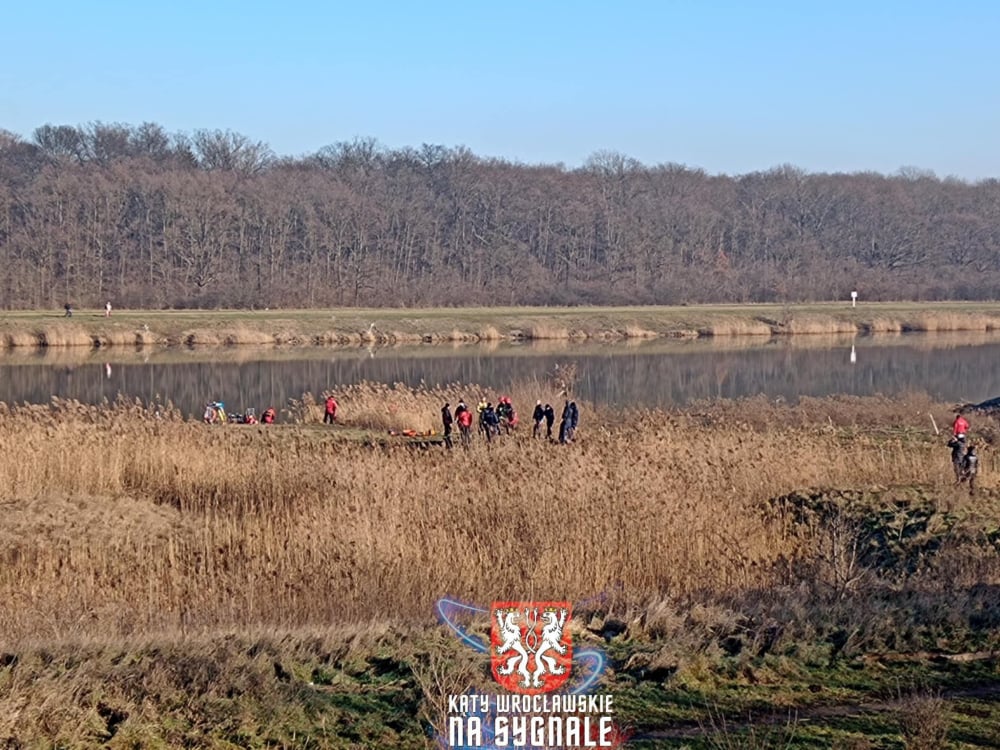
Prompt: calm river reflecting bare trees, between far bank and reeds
<box><xmin>0</xmin><ymin>334</ymin><xmax>1000</xmax><ymax>415</ymax></box>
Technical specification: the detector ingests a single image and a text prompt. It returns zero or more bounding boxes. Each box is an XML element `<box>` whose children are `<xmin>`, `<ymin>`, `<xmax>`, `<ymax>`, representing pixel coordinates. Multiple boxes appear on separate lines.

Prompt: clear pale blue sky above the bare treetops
<box><xmin>0</xmin><ymin>0</ymin><xmax>1000</xmax><ymax>181</ymax></box>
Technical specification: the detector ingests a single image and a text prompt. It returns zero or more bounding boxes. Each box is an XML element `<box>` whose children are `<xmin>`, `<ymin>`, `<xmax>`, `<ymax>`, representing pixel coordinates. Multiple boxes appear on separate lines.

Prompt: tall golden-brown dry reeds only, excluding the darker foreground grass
<box><xmin>0</xmin><ymin>384</ymin><xmax>991</xmax><ymax>642</ymax></box>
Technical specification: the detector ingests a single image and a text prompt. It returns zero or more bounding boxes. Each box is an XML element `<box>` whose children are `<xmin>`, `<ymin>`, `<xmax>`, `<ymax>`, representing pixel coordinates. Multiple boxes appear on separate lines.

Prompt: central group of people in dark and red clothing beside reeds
<box><xmin>441</xmin><ymin>396</ymin><xmax>580</xmax><ymax>448</ymax></box>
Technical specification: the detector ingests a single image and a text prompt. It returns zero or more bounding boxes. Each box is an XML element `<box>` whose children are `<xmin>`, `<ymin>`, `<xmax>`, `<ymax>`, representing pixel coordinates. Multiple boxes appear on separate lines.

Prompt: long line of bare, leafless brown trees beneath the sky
<box><xmin>0</xmin><ymin>123</ymin><xmax>1000</xmax><ymax>309</ymax></box>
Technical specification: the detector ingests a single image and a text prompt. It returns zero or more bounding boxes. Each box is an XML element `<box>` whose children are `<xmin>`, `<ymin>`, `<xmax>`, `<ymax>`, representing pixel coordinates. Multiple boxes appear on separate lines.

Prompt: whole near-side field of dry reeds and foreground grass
<box><xmin>0</xmin><ymin>385</ymin><xmax>1000</xmax><ymax>749</ymax></box>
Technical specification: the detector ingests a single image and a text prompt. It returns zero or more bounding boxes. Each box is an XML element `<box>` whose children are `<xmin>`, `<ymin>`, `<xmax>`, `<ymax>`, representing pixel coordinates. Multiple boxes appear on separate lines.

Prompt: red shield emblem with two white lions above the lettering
<box><xmin>490</xmin><ymin>602</ymin><xmax>573</xmax><ymax>695</ymax></box>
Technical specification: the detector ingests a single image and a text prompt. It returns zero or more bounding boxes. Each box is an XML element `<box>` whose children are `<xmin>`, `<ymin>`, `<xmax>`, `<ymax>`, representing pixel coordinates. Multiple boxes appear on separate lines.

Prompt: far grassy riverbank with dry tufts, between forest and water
<box><xmin>0</xmin><ymin>302</ymin><xmax>1000</xmax><ymax>348</ymax></box>
